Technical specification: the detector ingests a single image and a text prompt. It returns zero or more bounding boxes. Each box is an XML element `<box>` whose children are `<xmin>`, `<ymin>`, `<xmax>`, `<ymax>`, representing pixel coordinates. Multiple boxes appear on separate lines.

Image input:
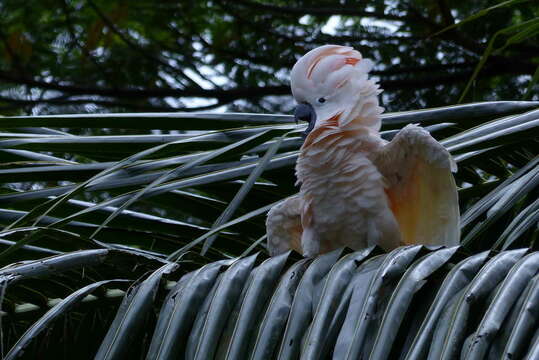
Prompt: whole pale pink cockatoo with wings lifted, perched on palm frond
<box><xmin>266</xmin><ymin>45</ymin><xmax>460</xmax><ymax>256</ymax></box>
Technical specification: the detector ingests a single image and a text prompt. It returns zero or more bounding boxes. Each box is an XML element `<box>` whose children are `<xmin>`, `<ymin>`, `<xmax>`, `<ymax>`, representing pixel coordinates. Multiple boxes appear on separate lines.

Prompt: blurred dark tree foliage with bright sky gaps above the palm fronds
<box><xmin>0</xmin><ymin>0</ymin><xmax>539</xmax><ymax>115</ymax></box>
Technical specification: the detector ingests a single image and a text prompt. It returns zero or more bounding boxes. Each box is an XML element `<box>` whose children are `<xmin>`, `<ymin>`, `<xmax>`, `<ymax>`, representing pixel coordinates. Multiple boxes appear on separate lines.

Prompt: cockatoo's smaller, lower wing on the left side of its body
<box><xmin>266</xmin><ymin>195</ymin><xmax>303</xmax><ymax>256</ymax></box>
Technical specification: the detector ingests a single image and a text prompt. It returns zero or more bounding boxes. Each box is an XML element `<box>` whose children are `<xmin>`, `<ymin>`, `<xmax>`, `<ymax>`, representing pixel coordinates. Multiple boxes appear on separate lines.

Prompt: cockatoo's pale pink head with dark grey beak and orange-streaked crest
<box><xmin>290</xmin><ymin>45</ymin><xmax>383</xmax><ymax>136</ymax></box>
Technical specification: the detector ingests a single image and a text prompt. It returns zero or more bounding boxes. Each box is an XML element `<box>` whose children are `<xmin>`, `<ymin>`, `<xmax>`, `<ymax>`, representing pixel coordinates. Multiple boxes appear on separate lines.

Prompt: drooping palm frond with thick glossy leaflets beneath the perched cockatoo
<box><xmin>1</xmin><ymin>245</ymin><xmax>539</xmax><ymax>359</ymax></box>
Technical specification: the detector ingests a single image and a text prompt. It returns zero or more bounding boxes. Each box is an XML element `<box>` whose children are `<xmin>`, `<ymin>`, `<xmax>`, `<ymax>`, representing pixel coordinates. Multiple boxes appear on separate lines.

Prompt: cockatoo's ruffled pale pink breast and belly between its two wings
<box><xmin>296</xmin><ymin>130</ymin><xmax>400</xmax><ymax>251</ymax></box>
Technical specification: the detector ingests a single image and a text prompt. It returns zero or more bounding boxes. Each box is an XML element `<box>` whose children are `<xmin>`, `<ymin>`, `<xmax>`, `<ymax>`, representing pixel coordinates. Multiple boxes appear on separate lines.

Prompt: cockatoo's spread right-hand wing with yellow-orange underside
<box><xmin>374</xmin><ymin>125</ymin><xmax>460</xmax><ymax>246</ymax></box>
